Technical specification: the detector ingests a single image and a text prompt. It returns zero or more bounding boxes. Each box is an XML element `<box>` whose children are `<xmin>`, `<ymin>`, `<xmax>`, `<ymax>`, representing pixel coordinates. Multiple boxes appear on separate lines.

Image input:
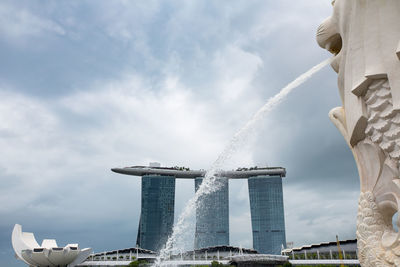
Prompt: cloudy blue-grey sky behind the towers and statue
<box><xmin>0</xmin><ymin>0</ymin><xmax>359</xmax><ymax>266</ymax></box>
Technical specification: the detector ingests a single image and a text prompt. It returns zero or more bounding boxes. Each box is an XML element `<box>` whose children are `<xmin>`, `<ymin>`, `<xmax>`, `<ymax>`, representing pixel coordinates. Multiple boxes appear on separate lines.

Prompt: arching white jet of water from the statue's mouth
<box><xmin>154</xmin><ymin>59</ymin><xmax>332</xmax><ymax>266</ymax></box>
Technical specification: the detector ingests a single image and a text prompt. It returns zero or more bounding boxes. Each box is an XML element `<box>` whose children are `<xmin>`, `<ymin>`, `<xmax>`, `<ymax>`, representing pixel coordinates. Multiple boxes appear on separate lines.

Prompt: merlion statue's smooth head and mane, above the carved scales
<box><xmin>317</xmin><ymin>0</ymin><xmax>400</xmax><ymax>146</ymax></box>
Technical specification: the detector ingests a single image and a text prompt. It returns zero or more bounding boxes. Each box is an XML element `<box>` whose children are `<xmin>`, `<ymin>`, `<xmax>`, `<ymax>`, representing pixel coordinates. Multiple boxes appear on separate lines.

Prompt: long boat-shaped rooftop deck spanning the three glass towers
<box><xmin>111</xmin><ymin>166</ymin><xmax>286</xmax><ymax>179</ymax></box>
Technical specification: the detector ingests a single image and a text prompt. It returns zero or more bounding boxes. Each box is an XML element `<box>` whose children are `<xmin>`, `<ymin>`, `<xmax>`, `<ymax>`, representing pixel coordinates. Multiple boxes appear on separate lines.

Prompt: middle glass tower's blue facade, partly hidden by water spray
<box><xmin>194</xmin><ymin>178</ymin><xmax>229</xmax><ymax>249</ymax></box>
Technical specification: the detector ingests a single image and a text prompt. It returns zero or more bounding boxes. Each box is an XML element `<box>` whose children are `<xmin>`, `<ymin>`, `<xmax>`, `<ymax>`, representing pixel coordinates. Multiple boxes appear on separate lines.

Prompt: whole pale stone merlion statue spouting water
<box><xmin>317</xmin><ymin>0</ymin><xmax>400</xmax><ymax>267</ymax></box>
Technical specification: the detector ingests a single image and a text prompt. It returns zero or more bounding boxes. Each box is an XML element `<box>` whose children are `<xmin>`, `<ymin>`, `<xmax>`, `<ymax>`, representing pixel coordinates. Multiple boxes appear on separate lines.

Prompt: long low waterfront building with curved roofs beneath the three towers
<box><xmin>78</xmin><ymin>243</ymin><xmax>360</xmax><ymax>267</ymax></box>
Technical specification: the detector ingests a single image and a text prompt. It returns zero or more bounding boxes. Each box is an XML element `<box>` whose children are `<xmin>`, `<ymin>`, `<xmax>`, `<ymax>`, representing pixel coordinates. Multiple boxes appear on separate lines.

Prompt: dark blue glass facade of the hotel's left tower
<box><xmin>136</xmin><ymin>175</ymin><xmax>175</xmax><ymax>251</ymax></box>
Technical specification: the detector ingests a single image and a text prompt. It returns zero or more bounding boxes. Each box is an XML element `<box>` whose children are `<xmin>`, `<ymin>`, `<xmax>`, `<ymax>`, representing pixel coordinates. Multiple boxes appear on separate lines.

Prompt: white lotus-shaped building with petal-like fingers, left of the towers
<box><xmin>11</xmin><ymin>224</ymin><xmax>92</xmax><ymax>267</ymax></box>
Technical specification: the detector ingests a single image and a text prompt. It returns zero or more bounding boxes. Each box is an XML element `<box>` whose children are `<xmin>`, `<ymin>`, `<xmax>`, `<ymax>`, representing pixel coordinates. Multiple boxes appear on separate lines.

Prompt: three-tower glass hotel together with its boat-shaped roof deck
<box><xmin>112</xmin><ymin>163</ymin><xmax>286</xmax><ymax>255</ymax></box>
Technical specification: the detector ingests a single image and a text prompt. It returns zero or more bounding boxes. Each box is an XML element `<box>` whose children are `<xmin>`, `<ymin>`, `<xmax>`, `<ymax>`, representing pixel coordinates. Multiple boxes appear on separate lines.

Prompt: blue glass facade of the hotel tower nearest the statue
<box><xmin>248</xmin><ymin>176</ymin><xmax>286</xmax><ymax>255</ymax></box>
